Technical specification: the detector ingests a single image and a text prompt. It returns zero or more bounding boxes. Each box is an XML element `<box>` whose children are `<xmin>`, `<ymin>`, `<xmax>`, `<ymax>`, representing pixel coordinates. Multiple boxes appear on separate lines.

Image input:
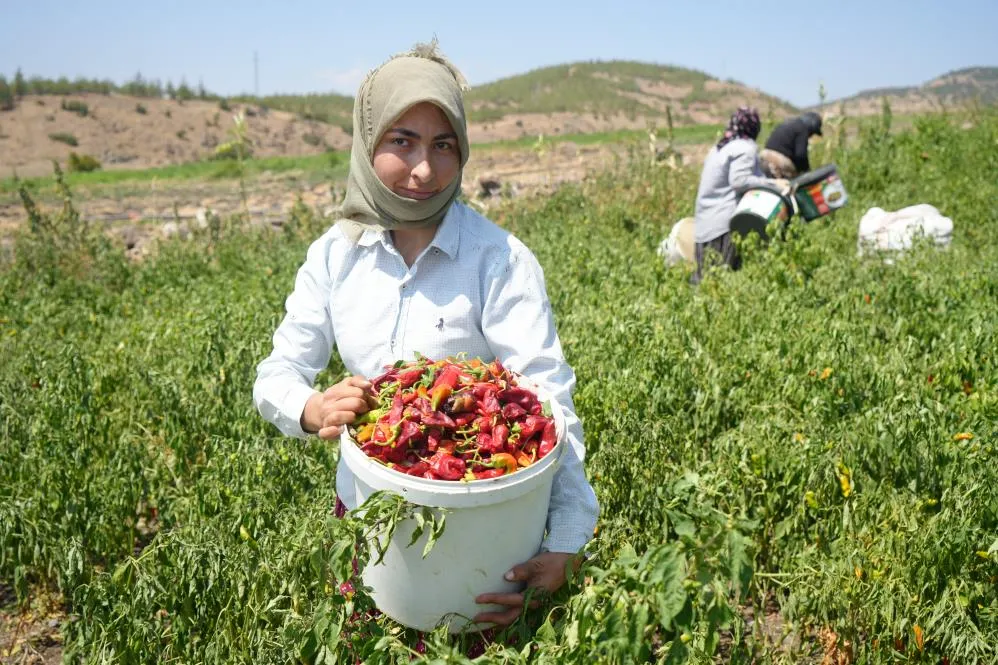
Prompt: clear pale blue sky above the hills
<box><xmin>0</xmin><ymin>0</ymin><xmax>998</xmax><ymax>106</ymax></box>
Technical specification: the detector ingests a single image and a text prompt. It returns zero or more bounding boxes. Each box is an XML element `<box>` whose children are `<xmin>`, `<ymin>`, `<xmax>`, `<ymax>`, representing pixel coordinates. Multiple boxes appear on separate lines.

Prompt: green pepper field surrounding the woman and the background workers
<box><xmin>0</xmin><ymin>109</ymin><xmax>998</xmax><ymax>665</ymax></box>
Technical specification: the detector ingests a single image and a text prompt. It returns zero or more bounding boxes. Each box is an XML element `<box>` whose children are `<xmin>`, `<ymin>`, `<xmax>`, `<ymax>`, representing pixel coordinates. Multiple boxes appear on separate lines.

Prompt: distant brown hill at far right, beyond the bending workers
<box><xmin>829</xmin><ymin>67</ymin><xmax>998</xmax><ymax>115</ymax></box>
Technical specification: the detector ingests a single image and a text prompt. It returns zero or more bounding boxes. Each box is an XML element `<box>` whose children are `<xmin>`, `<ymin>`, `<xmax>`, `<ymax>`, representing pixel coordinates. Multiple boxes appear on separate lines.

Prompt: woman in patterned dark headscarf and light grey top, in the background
<box><xmin>690</xmin><ymin>107</ymin><xmax>789</xmax><ymax>284</ymax></box>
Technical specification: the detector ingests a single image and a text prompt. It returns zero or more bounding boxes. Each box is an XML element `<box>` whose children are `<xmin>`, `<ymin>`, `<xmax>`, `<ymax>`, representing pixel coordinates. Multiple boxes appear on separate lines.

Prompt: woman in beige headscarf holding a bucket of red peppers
<box><xmin>253</xmin><ymin>45</ymin><xmax>598</xmax><ymax>625</ymax></box>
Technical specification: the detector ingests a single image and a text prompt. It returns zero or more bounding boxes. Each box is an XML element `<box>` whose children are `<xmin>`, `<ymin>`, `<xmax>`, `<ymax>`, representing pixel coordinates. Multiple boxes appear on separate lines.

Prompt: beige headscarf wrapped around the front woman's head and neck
<box><xmin>337</xmin><ymin>41</ymin><xmax>468</xmax><ymax>242</ymax></box>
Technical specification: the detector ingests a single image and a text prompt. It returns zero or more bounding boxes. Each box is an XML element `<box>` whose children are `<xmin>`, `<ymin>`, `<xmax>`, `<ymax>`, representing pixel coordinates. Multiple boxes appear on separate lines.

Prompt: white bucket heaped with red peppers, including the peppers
<box><xmin>341</xmin><ymin>357</ymin><xmax>565</xmax><ymax>632</ymax></box>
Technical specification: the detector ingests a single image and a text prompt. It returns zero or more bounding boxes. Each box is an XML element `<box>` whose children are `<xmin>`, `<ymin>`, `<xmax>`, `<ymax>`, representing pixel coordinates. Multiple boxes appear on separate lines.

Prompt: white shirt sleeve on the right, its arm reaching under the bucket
<box><xmin>482</xmin><ymin>241</ymin><xmax>599</xmax><ymax>552</ymax></box>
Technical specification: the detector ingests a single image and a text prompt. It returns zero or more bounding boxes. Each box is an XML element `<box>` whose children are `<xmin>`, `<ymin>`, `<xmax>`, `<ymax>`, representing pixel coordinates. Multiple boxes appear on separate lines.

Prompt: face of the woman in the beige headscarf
<box><xmin>374</xmin><ymin>102</ymin><xmax>461</xmax><ymax>200</ymax></box>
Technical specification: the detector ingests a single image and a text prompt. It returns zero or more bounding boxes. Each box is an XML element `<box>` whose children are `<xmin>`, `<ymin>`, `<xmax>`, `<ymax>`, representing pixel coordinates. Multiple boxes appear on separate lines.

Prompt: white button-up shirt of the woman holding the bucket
<box><xmin>253</xmin><ymin>203</ymin><xmax>599</xmax><ymax>552</ymax></box>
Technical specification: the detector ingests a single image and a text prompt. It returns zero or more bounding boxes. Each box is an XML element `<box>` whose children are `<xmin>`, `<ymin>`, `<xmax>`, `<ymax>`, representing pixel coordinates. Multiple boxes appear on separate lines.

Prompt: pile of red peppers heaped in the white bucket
<box><xmin>350</xmin><ymin>356</ymin><xmax>558</xmax><ymax>481</ymax></box>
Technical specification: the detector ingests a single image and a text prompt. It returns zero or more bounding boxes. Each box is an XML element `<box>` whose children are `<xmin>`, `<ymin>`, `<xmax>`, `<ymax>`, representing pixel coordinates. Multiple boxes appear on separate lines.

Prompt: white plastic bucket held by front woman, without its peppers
<box><xmin>340</xmin><ymin>380</ymin><xmax>567</xmax><ymax>633</ymax></box>
